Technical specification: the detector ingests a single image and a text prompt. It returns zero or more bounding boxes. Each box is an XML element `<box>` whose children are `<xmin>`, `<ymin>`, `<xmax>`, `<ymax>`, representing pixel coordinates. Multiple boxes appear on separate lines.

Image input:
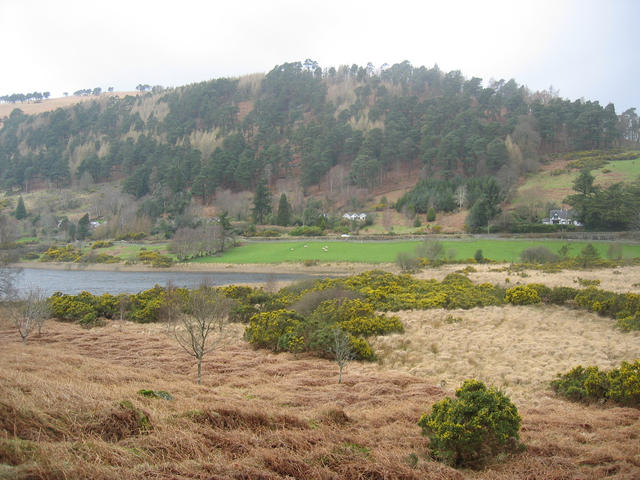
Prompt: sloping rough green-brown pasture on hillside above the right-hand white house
<box><xmin>513</xmin><ymin>158</ymin><xmax>640</xmax><ymax>205</ymax></box>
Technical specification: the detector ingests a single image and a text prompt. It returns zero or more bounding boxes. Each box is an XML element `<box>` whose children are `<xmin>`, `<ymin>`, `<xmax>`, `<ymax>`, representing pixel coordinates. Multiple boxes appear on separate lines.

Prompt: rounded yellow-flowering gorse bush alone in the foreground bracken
<box><xmin>418</xmin><ymin>380</ymin><xmax>521</xmax><ymax>468</ymax></box>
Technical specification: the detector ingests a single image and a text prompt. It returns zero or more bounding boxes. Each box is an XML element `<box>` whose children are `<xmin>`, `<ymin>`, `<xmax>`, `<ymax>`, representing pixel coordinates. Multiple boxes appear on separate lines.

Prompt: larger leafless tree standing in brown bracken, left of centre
<box><xmin>172</xmin><ymin>286</ymin><xmax>232</xmax><ymax>385</ymax></box>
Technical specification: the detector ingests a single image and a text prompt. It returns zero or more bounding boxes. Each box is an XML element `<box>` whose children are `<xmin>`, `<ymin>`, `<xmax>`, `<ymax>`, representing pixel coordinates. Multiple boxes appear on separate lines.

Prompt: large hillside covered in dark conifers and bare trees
<box><xmin>0</xmin><ymin>60</ymin><xmax>640</xmax><ymax>231</ymax></box>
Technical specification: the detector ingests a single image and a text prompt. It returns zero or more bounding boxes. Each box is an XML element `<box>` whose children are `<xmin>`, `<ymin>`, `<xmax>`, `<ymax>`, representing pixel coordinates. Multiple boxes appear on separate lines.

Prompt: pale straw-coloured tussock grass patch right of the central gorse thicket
<box><xmin>372</xmin><ymin>305</ymin><xmax>640</xmax><ymax>405</ymax></box>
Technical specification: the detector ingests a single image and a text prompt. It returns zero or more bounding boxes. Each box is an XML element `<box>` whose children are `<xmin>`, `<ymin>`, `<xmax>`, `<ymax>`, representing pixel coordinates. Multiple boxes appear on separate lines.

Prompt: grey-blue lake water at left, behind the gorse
<box><xmin>11</xmin><ymin>268</ymin><xmax>309</xmax><ymax>295</ymax></box>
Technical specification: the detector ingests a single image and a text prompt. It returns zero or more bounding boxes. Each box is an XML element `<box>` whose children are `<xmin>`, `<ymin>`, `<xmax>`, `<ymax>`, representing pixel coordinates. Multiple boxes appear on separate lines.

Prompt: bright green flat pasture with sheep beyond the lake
<box><xmin>194</xmin><ymin>239</ymin><xmax>640</xmax><ymax>264</ymax></box>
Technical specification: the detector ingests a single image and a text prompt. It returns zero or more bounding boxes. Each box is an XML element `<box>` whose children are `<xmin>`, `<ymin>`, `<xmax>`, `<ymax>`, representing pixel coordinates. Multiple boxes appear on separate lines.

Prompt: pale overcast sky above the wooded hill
<box><xmin>0</xmin><ymin>0</ymin><xmax>640</xmax><ymax>113</ymax></box>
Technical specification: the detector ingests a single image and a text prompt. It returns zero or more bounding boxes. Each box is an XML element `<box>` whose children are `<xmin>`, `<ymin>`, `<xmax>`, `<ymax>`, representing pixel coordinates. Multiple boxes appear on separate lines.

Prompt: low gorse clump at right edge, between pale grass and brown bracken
<box><xmin>551</xmin><ymin>360</ymin><xmax>640</xmax><ymax>407</ymax></box>
